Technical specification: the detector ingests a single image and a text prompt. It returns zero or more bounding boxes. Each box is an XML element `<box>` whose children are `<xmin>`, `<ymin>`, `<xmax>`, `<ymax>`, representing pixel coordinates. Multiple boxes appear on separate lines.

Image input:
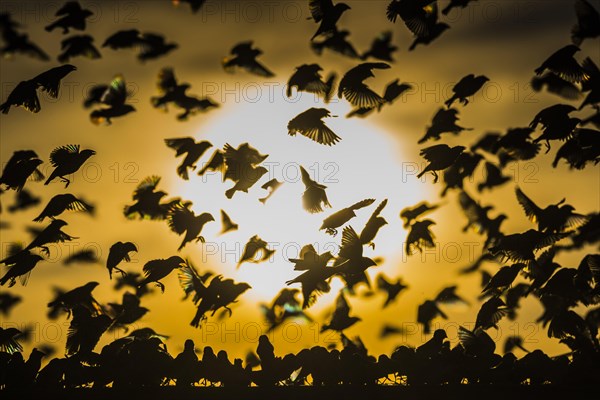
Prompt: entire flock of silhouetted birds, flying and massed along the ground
<box><xmin>0</xmin><ymin>0</ymin><xmax>600</xmax><ymax>388</ymax></box>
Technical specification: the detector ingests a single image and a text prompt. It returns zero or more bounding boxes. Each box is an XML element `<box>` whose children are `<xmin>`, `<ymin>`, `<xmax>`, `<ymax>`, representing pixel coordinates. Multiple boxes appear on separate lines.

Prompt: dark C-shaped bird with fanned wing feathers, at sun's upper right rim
<box><xmin>338</xmin><ymin>63</ymin><xmax>391</xmax><ymax>108</ymax></box>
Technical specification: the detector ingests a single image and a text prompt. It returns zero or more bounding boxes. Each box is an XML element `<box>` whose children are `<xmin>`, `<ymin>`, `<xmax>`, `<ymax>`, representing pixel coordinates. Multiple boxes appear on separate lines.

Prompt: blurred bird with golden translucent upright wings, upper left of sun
<box><xmin>86</xmin><ymin>74</ymin><xmax>136</xmax><ymax>125</ymax></box>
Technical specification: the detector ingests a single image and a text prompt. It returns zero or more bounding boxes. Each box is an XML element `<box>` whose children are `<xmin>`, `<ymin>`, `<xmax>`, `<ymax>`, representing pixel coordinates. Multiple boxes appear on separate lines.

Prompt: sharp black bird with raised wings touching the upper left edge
<box><xmin>0</xmin><ymin>64</ymin><xmax>77</xmax><ymax>114</ymax></box>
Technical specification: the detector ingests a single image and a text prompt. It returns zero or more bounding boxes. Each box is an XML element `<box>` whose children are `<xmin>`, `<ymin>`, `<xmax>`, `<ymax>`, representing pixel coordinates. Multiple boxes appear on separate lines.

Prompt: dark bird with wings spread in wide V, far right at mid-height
<box><xmin>515</xmin><ymin>188</ymin><xmax>588</xmax><ymax>233</ymax></box>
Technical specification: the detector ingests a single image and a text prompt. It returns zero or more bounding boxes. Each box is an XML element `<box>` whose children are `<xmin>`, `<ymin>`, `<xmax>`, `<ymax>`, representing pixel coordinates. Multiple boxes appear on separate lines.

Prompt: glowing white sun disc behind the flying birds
<box><xmin>175</xmin><ymin>84</ymin><xmax>425</xmax><ymax>301</ymax></box>
